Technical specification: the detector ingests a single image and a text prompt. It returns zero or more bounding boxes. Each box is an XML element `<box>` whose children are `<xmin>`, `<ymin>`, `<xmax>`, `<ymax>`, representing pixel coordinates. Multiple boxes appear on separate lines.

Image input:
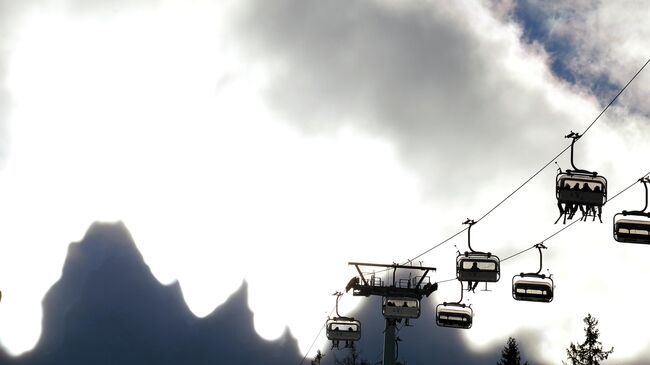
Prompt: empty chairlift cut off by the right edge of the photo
<box><xmin>614</xmin><ymin>177</ymin><xmax>650</xmax><ymax>244</ymax></box>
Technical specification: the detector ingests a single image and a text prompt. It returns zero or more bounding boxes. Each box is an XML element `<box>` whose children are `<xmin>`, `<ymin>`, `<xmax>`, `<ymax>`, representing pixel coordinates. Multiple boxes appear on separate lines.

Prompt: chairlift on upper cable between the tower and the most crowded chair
<box><xmin>456</xmin><ymin>219</ymin><xmax>501</xmax><ymax>283</ymax></box>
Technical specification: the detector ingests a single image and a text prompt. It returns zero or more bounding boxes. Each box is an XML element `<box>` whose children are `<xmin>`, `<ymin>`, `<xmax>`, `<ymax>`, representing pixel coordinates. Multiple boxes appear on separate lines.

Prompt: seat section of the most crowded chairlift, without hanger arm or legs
<box><xmin>555</xmin><ymin>172</ymin><xmax>607</xmax><ymax>206</ymax></box>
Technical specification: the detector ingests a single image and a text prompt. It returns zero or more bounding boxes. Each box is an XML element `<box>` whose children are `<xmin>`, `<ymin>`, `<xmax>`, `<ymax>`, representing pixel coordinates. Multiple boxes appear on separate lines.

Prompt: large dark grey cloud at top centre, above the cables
<box><xmin>230</xmin><ymin>0</ymin><xmax>580</xmax><ymax>199</ymax></box>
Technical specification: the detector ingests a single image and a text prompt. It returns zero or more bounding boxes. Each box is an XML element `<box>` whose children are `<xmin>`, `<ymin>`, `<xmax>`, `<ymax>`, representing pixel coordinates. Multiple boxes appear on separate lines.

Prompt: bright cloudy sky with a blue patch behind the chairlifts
<box><xmin>0</xmin><ymin>0</ymin><xmax>650</xmax><ymax>363</ymax></box>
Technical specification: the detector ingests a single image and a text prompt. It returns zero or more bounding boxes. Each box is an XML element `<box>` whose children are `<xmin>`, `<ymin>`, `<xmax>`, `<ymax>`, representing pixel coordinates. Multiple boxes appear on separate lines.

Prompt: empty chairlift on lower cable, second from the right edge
<box><xmin>512</xmin><ymin>243</ymin><xmax>555</xmax><ymax>303</ymax></box>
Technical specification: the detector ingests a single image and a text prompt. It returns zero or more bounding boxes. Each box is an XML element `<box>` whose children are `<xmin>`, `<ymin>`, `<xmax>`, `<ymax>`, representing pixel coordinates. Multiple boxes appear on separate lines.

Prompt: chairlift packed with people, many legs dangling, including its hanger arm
<box><xmin>555</xmin><ymin>132</ymin><xmax>607</xmax><ymax>223</ymax></box>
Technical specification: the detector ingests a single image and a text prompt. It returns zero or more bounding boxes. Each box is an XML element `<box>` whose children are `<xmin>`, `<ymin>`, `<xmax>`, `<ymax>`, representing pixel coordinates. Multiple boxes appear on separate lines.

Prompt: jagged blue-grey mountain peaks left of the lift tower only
<box><xmin>0</xmin><ymin>223</ymin><xmax>302</xmax><ymax>365</ymax></box>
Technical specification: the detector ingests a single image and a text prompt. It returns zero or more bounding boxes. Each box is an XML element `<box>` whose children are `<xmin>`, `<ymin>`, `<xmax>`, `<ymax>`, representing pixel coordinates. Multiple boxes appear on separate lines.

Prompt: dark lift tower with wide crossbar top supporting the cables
<box><xmin>345</xmin><ymin>262</ymin><xmax>438</xmax><ymax>365</ymax></box>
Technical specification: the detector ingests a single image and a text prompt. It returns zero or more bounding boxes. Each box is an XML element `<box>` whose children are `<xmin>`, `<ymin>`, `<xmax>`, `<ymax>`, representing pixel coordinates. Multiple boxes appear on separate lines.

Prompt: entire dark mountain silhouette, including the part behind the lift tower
<box><xmin>0</xmin><ymin>223</ymin><xmax>560</xmax><ymax>365</ymax></box>
